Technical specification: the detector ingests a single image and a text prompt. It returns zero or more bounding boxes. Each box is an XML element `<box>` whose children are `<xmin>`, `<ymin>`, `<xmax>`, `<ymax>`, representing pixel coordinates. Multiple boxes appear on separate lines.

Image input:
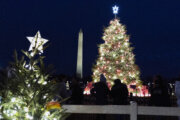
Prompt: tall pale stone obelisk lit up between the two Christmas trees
<box><xmin>76</xmin><ymin>30</ymin><xmax>83</xmax><ymax>79</ymax></box>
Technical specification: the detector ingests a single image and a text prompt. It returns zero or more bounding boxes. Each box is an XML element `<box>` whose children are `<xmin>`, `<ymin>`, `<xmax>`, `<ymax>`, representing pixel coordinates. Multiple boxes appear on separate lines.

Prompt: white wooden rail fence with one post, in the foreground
<box><xmin>63</xmin><ymin>102</ymin><xmax>180</xmax><ymax>120</ymax></box>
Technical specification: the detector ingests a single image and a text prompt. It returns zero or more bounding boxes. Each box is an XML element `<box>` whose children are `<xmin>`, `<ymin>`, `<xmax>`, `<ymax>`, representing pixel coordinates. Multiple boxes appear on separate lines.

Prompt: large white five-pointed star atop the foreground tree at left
<box><xmin>27</xmin><ymin>31</ymin><xmax>48</xmax><ymax>56</ymax></box>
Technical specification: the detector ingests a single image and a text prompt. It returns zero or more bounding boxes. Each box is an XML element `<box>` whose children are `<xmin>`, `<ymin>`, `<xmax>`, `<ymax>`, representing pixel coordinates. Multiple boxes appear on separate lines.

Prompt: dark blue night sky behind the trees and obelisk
<box><xmin>0</xmin><ymin>0</ymin><xmax>180</xmax><ymax>77</ymax></box>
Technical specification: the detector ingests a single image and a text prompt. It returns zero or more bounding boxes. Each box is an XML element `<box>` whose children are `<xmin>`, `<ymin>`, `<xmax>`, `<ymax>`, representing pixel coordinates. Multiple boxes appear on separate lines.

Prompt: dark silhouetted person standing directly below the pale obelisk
<box><xmin>70</xmin><ymin>78</ymin><xmax>83</xmax><ymax>105</ymax></box>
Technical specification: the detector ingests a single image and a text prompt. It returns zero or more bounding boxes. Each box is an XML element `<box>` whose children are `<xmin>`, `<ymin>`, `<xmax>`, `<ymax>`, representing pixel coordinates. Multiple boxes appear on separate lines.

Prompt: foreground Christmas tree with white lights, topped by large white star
<box><xmin>0</xmin><ymin>32</ymin><xmax>66</xmax><ymax>120</ymax></box>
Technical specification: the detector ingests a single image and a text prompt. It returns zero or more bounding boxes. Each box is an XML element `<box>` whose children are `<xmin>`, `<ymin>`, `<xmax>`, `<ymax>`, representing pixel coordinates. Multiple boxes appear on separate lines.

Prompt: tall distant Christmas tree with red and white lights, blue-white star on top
<box><xmin>92</xmin><ymin>6</ymin><xmax>141</xmax><ymax>86</ymax></box>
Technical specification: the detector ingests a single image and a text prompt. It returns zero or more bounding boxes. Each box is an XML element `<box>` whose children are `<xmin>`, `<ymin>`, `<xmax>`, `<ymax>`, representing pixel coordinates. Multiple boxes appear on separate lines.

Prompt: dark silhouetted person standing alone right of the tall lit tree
<box><xmin>150</xmin><ymin>75</ymin><xmax>170</xmax><ymax>106</ymax></box>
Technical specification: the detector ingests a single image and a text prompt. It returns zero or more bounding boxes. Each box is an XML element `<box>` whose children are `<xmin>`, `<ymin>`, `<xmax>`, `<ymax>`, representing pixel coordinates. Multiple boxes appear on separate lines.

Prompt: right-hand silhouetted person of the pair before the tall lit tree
<box><xmin>111</xmin><ymin>79</ymin><xmax>128</xmax><ymax>105</ymax></box>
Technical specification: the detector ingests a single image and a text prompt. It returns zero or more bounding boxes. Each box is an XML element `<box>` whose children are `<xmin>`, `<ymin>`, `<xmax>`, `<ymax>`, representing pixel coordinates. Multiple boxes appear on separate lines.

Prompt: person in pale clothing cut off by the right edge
<box><xmin>175</xmin><ymin>78</ymin><xmax>180</xmax><ymax>120</ymax></box>
